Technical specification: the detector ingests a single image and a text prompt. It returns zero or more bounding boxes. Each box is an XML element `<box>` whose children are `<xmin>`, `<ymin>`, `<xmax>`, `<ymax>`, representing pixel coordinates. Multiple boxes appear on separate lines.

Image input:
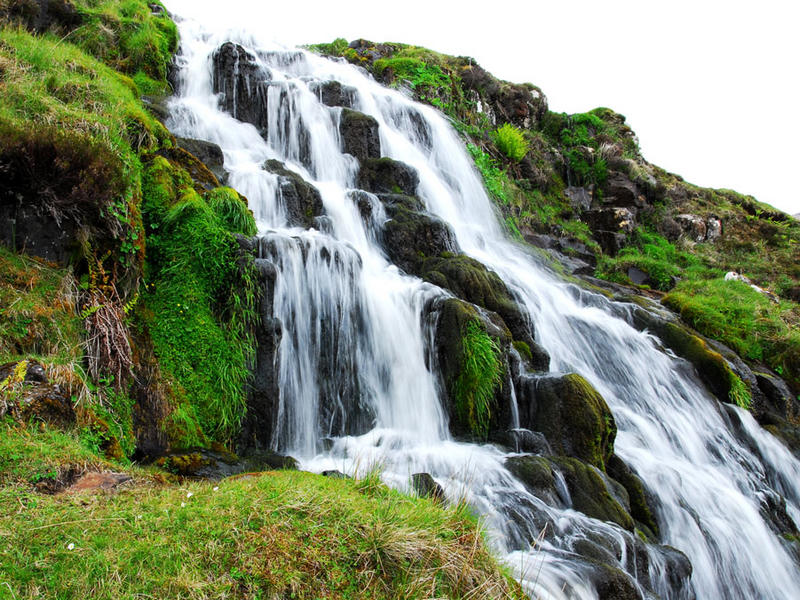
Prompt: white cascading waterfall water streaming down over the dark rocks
<box><xmin>162</xmin><ymin>0</ymin><xmax>800</xmax><ymax>599</ymax></box>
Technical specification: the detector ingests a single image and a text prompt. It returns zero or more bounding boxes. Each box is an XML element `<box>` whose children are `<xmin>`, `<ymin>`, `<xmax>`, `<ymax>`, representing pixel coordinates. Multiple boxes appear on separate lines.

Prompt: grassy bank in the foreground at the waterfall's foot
<box><xmin>0</xmin><ymin>423</ymin><xmax>524</xmax><ymax>600</ymax></box>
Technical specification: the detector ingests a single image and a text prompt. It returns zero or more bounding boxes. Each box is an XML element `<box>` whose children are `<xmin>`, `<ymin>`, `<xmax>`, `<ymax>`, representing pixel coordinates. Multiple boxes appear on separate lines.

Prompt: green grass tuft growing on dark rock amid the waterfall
<box><xmin>453</xmin><ymin>319</ymin><xmax>503</xmax><ymax>438</ymax></box>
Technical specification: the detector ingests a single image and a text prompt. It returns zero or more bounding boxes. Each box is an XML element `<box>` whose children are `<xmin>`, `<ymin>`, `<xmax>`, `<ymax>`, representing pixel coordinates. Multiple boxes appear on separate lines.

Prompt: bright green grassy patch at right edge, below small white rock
<box><xmin>664</xmin><ymin>278</ymin><xmax>800</xmax><ymax>386</ymax></box>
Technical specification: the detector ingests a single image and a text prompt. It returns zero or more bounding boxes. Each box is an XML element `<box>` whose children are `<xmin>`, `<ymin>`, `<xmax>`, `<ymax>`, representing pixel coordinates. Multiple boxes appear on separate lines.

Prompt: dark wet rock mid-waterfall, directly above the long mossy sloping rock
<box><xmin>381</xmin><ymin>204</ymin><xmax>458</xmax><ymax>273</ymax></box>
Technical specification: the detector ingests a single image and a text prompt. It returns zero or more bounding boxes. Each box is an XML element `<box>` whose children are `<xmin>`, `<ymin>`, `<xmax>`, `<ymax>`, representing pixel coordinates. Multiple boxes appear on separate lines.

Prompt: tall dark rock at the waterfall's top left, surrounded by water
<box><xmin>211</xmin><ymin>42</ymin><xmax>272</xmax><ymax>133</ymax></box>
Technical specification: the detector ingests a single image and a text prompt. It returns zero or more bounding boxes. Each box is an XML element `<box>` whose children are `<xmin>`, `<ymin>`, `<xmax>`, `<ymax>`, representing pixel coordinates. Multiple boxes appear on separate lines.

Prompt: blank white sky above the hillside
<box><xmin>165</xmin><ymin>0</ymin><xmax>800</xmax><ymax>213</ymax></box>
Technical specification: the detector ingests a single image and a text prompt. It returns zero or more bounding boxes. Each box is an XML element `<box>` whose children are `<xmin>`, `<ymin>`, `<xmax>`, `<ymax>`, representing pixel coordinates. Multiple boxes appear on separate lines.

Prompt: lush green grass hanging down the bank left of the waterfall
<box><xmin>137</xmin><ymin>159</ymin><xmax>255</xmax><ymax>443</ymax></box>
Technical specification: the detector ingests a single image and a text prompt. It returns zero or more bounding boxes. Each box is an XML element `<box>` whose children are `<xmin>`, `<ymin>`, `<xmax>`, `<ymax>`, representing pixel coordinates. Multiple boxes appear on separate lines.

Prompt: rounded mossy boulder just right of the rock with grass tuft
<box><xmin>517</xmin><ymin>373</ymin><xmax>617</xmax><ymax>469</ymax></box>
